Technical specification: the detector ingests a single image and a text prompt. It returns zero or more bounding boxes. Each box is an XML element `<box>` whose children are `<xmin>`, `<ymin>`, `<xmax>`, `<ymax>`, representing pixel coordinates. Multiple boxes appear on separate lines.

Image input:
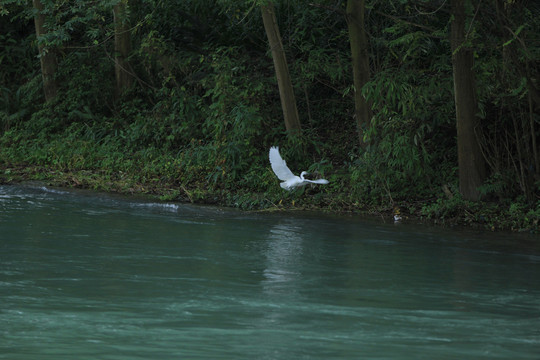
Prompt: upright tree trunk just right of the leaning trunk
<box><xmin>346</xmin><ymin>0</ymin><xmax>371</xmax><ymax>147</ymax></box>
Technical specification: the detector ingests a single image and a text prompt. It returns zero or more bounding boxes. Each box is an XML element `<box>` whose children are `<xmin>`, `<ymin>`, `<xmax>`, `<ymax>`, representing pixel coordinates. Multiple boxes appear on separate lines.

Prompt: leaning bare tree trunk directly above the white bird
<box><xmin>261</xmin><ymin>2</ymin><xmax>301</xmax><ymax>133</ymax></box>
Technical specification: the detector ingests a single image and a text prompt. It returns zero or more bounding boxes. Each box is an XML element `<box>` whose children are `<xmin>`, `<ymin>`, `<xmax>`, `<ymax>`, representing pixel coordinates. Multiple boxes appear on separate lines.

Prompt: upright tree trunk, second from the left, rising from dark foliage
<box><xmin>113</xmin><ymin>0</ymin><xmax>133</xmax><ymax>97</ymax></box>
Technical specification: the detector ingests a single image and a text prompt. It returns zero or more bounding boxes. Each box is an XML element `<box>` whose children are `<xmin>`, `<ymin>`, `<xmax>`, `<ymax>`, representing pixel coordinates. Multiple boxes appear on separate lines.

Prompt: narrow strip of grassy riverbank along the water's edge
<box><xmin>0</xmin><ymin>164</ymin><xmax>540</xmax><ymax>234</ymax></box>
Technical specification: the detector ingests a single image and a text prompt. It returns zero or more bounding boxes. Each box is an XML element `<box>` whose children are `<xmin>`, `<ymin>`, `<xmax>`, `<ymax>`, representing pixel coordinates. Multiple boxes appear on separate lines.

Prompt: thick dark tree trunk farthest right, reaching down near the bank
<box><xmin>450</xmin><ymin>0</ymin><xmax>486</xmax><ymax>200</ymax></box>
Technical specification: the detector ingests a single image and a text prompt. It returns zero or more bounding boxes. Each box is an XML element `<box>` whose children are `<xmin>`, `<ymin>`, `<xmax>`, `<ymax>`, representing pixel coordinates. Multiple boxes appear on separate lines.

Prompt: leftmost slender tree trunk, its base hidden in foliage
<box><xmin>33</xmin><ymin>0</ymin><xmax>58</xmax><ymax>101</ymax></box>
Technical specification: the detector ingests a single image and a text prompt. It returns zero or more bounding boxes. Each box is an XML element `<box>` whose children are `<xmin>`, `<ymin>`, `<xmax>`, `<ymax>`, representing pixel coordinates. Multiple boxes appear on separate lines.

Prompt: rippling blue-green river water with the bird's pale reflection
<box><xmin>0</xmin><ymin>186</ymin><xmax>540</xmax><ymax>360</ymax></box>
